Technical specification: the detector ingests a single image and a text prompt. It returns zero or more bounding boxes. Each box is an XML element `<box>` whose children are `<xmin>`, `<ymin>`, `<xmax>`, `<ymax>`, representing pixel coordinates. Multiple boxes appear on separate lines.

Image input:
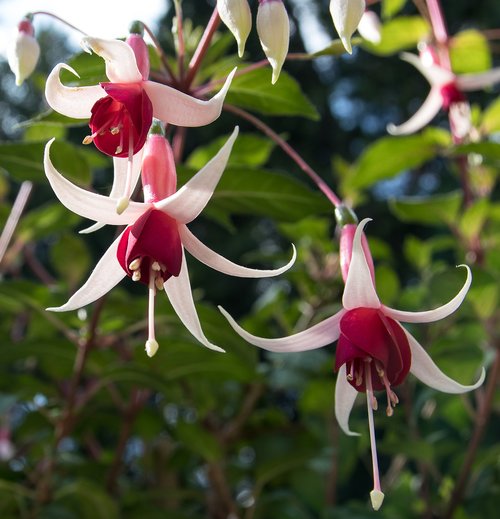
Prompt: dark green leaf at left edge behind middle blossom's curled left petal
<box><xmin>0</xmin><ymin>141</ymin><xmax>90</xmax><ymax>185</ymax></box>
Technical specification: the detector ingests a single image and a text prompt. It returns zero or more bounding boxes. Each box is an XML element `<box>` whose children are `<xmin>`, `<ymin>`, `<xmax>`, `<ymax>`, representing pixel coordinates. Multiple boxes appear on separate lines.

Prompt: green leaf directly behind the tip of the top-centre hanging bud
<box><xmin>226</xmin><ymin>68</ymin><xmax>319</xmax><ymax>121</ymax></box>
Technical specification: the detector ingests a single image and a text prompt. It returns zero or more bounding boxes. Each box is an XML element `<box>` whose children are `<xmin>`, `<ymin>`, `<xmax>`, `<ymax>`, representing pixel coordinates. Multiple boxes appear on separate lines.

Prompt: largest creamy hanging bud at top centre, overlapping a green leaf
<box><xmin>257</xmin><ymin>0</ymin><xmax>290</xmax><ymax>85</ymax></box>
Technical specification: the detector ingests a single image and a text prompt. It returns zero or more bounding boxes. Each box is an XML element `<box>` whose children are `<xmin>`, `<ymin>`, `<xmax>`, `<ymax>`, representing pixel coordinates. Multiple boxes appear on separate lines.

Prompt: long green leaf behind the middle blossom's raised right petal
<box><xmin>178</xmin><ymin>167</ymin><xmax>331</xmax><ymax>222</ymax></box>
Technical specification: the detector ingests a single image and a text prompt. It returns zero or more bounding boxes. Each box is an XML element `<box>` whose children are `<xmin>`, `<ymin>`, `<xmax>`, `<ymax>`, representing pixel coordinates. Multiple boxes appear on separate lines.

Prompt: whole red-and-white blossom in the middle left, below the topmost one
<box><xmin>44</xmin><ymin>128</ymin><xmax>296</xmax><ymax>357</ymax></box>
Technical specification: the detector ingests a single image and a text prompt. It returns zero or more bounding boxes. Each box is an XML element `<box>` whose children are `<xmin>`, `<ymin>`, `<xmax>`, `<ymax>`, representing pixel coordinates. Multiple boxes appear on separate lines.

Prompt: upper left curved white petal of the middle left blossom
<box><xmin>43</xmin><ymin>139</ymin><xmax>149</xmax><ymax>225</ymax></box>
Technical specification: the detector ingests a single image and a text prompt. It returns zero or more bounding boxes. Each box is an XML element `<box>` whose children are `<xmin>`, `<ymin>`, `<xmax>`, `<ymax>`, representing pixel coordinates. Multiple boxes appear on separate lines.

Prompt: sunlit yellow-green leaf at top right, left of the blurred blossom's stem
<box><xmin>363</xmin><ymin>16</ymin><xmax>429</xmax><ymax>56</ymax></box>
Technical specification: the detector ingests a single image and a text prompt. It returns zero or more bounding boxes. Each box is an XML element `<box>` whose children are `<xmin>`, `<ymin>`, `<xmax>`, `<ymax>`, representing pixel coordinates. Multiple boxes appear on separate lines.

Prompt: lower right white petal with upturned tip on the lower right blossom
<box><xmin>403</xmin><ymin>328</ymin><xmax>485</xmax><ymax>394</ymax></box>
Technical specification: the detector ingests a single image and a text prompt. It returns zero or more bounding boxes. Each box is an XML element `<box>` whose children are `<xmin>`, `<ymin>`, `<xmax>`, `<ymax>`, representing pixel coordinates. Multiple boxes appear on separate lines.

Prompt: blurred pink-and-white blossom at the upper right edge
<box><xmin>387</xmin><ymin>44</ymin><xmax>500</xmax><ymax>138</ymax></box>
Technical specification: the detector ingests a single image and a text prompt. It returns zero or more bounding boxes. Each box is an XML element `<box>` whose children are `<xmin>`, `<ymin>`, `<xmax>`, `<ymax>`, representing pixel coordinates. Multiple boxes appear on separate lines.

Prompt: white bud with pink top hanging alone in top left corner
<box><xmin>7</xmin><ymin>17</ymin><xmax>40</xmax><ymax>86</ymax></box>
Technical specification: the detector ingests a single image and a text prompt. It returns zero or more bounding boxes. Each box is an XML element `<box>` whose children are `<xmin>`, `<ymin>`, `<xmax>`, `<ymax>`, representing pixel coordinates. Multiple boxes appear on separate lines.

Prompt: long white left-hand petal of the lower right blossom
<box><xmin>219</xmin><ymin>306</ymin><xmax>345</xmax><ymax>352</ymax></box>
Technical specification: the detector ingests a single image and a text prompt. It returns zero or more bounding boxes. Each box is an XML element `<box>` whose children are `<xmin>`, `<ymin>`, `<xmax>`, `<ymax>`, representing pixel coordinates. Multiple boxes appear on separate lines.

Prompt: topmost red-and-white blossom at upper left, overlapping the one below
<box><xmin>45</xmin><ymin>37</ymin><xmax>235</xmax><ymax>213</ymax></box>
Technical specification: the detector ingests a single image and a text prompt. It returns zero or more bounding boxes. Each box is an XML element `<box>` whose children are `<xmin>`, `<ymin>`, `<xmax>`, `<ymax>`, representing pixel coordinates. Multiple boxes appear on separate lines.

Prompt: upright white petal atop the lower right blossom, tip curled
<box><xmin>342</xmin><ymin>218</ymin><xmax>380</xmax><ymax>310</ymax></box>
